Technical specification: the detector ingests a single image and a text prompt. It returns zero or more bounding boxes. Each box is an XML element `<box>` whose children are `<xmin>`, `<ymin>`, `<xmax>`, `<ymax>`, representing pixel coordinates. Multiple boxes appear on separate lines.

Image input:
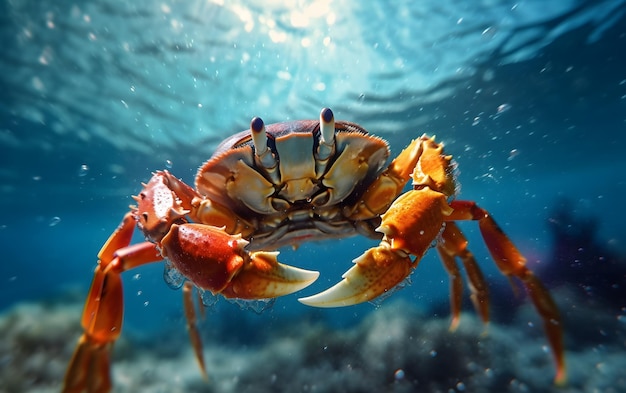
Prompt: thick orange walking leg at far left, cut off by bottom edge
<box><xmin>63</xmin><ymin>213</ymin><xmax>162</xmax><ymax>392</ymax></box>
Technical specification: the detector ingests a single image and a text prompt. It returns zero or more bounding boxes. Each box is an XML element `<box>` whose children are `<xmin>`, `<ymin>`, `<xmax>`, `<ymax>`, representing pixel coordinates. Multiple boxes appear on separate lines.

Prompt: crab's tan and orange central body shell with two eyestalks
<box><xmin>196</xmin><ymin>110</ymin><xmax>389</xmax><ymax>250</ymax></box>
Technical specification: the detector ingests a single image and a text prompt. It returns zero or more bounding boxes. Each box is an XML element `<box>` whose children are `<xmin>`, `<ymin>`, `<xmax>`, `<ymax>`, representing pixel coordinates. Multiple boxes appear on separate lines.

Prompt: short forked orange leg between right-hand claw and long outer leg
<box><xmin>437</xmin><ymin>222</ymin><xmax>489</xmax><ymax>331</ymax></box>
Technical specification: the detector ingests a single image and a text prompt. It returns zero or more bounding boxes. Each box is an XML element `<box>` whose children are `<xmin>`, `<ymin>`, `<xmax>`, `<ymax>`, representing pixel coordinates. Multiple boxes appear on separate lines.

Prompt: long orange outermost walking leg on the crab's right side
<box><xmin>446</xmin><ymin>201</ymin><xmax>566</xmax><ymax>384</ymax></box>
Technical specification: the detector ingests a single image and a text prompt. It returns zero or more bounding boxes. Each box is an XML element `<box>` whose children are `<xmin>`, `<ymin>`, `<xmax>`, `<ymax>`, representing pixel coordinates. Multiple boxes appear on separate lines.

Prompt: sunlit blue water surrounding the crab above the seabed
<box><xmin>0</xmin><ymin>0</ymin><xmax>626</xmax><ymax>390</ymax></box>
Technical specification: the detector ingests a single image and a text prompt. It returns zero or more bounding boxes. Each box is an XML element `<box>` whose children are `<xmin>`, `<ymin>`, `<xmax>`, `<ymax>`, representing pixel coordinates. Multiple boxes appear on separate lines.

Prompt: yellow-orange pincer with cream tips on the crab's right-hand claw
<box><xmin>298</xmin><ymin>243</ymin><xmax>414</xmax><ymax>307</ymax></box>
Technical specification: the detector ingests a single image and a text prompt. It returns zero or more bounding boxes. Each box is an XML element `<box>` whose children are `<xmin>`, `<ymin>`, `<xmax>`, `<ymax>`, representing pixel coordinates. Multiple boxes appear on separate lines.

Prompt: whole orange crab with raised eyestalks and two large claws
<box><xmin>63</xmin><ymin>108</ymin><xmax>566</xmax><ymax>392</ymax></box>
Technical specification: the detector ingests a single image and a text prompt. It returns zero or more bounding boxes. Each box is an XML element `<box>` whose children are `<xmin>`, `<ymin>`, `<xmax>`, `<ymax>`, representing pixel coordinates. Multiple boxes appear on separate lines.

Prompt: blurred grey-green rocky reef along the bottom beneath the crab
<box><xmin>0</xmin><ymin>293</ymin><xmax>626</xmax><ymax>393</ymax></box>
